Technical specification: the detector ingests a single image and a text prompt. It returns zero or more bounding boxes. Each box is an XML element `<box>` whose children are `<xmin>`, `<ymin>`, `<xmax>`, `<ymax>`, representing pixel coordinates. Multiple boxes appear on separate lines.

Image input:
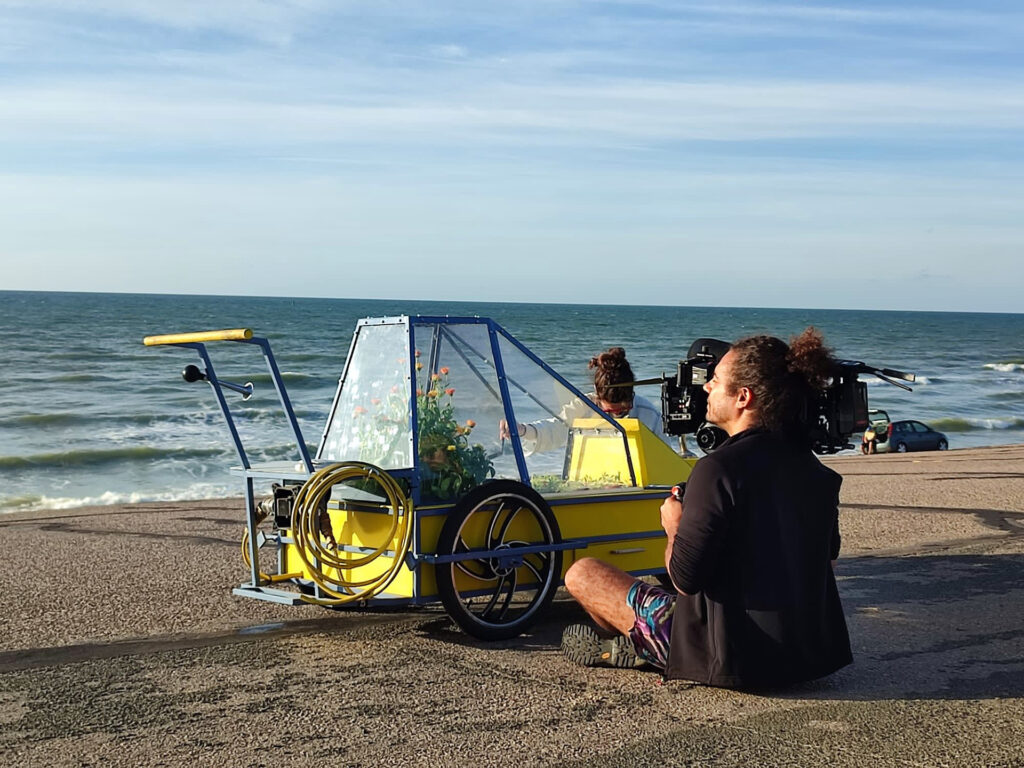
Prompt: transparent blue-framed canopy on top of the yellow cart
<box><xmin>316</xmin><ymin>316</ymin><xmax>635</xmax><ymax>501</ymax></box>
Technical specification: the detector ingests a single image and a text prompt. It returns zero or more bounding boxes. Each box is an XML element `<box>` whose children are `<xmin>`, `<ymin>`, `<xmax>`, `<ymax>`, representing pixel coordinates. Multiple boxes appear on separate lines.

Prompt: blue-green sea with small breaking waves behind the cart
<box><xmin>0</xmin><ymin>291</ymin><xmax>1024</xmax><ymax>513</ymax></box>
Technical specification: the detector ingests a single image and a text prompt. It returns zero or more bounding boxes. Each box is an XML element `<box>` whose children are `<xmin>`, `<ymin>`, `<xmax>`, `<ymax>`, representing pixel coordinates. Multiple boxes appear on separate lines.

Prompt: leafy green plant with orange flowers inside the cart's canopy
<box><xmin>416</xmin><ymin>368</ymin><xmax>495</xmax><ymax>501</ymax></box>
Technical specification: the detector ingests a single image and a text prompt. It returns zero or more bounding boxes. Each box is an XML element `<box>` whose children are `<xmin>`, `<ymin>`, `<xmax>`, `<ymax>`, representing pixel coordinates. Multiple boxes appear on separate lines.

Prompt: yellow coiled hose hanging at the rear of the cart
<box><xmin>292</xmin><ymin>462</ymin><xmax>413</xmax><ymax>605</ymax></box>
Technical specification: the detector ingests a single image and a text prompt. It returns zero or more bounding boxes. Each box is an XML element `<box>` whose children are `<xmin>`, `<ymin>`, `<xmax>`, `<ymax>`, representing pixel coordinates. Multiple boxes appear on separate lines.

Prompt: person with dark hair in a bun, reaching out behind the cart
<box><xmin>499</xmin><ymin>347</ymin><xmax>676</xmax><ymax>455</ymax></box>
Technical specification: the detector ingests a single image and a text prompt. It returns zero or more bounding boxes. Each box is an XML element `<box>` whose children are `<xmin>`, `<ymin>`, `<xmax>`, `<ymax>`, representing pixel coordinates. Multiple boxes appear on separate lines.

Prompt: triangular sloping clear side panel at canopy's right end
<box><xmin>499</xmin><ymin>337</ymin><xmax>632</xmax><ymax>493</ymax></box>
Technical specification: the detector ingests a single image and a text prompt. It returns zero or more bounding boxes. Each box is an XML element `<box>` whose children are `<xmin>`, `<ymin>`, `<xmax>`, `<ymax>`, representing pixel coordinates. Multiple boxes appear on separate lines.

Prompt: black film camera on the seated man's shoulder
<box><xmin>662</xmin><ymin>339</ymin><xmax>914</xmax><ymax>454</ymax></box>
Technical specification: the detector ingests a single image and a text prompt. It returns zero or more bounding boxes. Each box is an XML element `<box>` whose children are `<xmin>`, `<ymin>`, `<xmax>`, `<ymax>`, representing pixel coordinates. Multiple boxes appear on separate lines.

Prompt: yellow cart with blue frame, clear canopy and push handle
<box><xmin>144</xmin><ymin>315</ymin><xmax>695</xmax><ymax>640</ymax></box>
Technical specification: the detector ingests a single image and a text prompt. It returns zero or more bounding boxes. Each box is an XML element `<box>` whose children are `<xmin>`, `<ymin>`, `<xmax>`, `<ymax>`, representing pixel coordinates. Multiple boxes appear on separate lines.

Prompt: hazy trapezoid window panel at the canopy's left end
<box><xmin>318</xmin><ymin>322</ymin><xmax>413</xmax><ymax>469</ymax></box>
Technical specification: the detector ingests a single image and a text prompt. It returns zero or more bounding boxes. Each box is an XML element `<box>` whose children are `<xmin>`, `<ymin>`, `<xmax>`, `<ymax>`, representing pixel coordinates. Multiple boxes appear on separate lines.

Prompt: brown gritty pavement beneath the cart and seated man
<box><xmin>0</xmin><ymin>445</ymin><xmax>1024</xmax><ymax>768</ymax></box>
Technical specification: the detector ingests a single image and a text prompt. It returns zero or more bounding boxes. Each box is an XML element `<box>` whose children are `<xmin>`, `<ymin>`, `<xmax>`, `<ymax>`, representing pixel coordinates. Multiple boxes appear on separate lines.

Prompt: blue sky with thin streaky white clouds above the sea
<box><xmin>0</xmin><ymin>0</ymin><xmax>1024</xmax><ymax>312</ymax></box>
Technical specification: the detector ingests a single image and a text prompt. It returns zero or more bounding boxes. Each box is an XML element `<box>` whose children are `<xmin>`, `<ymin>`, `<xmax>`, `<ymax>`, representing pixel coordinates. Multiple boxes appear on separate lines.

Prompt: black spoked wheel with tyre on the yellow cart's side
<box><xmin>434</xmin><ymin>480</ymin><xmax>562</xmax><ymax>640</ymax></box>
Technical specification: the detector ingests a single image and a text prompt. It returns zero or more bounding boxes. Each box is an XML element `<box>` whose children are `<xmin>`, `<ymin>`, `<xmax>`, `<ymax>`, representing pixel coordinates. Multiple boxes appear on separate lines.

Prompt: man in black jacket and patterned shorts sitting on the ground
<box><xmin>562</xmin><ymin>328</ymin><xmax>852</xmax><ymax>688</ymax></box>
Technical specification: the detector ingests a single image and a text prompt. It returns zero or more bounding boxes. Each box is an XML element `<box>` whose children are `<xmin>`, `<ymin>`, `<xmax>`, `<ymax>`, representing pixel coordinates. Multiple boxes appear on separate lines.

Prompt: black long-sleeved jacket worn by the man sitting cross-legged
<box><xmin>666</xmin><ymin>428</ymin><xmax>852</xmax><ymax>687</ymax></box>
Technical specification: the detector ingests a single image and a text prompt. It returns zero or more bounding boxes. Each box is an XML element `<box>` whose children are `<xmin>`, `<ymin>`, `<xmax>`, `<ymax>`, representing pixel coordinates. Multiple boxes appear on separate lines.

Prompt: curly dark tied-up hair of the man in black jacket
<box><xmin>731</xmin><ymin>326</ymin><xmax>836</xmax><ymax>439</ymax></box>
